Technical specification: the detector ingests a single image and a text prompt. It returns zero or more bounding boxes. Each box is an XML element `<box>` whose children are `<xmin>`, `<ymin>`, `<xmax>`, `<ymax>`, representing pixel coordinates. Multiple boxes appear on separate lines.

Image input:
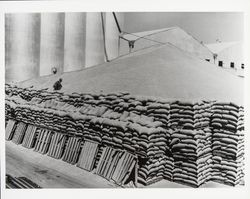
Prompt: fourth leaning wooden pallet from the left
<box><xmin>34</xmin><ymin>129</ymin><xmax>52</xmax><ymax>154</ymax></box>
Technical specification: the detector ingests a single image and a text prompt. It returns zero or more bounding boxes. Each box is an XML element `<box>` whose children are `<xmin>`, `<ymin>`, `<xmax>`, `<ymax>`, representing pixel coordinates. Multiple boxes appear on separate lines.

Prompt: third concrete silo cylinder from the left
<box><xmin>64</xmin><ymin>13</ymin><xmax>86</xmax><ymax>72</ymax></box>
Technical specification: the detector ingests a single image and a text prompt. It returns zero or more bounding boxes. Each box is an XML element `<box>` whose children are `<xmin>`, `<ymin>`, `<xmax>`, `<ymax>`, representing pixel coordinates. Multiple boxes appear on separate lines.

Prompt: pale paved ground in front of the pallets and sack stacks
<box><xmin>6</xmin><ymin>141</ymin><xmax>228</xmax><ymax>188</ymax></box>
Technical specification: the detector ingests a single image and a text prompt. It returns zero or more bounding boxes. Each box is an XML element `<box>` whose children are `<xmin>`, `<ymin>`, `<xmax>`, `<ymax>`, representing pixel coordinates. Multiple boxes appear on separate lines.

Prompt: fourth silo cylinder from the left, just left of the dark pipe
<box><xmin>85</xmin><ymin>12</ymin><xmax>105</xmax><ymax>67</ymax></box>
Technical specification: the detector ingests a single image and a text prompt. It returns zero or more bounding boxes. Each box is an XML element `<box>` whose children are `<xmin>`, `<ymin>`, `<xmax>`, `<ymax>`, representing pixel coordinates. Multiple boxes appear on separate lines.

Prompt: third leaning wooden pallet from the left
<box><xmin>22</xmin><ymin>124</ymin><xmax>38</xmax><ymax>149</ymax></box>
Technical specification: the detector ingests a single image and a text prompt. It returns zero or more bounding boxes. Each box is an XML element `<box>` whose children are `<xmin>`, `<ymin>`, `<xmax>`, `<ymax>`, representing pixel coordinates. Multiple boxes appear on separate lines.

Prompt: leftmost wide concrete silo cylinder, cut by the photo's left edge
<box><xmin>5</xmin><ymin>13</ymin><xmax>40</xmax><ymax>82</ymax></box>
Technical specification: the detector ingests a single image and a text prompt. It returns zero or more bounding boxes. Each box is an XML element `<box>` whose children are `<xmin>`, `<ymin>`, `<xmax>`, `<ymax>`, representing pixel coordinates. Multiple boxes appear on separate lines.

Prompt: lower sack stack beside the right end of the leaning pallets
<box><xmin>134</xmin><ymin>126</ymin><xmax>173</xmax><ymax>185</ymax></box>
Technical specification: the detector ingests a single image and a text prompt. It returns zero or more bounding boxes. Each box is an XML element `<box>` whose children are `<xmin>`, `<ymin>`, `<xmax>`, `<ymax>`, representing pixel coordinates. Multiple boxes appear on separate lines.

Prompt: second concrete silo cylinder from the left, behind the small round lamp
<box><xmin>40</xmin><ymin>13</ymin><xmax>65</xmax><ymax>76</ymax></box>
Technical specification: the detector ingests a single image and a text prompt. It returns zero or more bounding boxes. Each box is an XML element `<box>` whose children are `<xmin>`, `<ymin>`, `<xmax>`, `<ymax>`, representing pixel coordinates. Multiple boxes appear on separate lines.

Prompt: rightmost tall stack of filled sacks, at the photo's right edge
<box><xmin>211</xmin><ymin>103</ymin><xmax>244</xmax><ymax>186</ymax></box>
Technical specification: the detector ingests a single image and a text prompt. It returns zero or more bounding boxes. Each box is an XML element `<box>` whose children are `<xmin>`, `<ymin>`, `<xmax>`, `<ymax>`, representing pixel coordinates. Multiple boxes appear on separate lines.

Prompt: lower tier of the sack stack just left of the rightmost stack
<box><xmin>170</xmin><ymin>128</ymin><xmax>212</xmax><ymax>187</ymax></box>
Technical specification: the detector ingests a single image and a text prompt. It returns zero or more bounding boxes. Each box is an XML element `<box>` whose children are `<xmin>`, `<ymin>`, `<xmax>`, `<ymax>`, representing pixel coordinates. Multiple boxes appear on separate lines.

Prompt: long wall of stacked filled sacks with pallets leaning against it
<box><xmin>5</xmin><ymin>85</ymin><xmax>244</xmax><ymax>187</ymax></box>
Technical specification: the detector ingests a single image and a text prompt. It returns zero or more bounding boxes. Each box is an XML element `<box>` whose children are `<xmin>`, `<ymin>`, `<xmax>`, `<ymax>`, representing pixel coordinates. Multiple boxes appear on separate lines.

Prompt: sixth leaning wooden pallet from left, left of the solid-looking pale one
<box><xmin>62</xmin><ymin>137</ymin><xmax>82</xmax><ymax>164</ymax></box>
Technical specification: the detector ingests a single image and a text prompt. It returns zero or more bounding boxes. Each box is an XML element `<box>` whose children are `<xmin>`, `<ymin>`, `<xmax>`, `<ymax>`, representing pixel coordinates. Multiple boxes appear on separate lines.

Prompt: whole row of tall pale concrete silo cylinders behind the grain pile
<box><xmin>5</xmin><ymin>12</ymin><xmax>123</xmax><ymax>82</ymax></box>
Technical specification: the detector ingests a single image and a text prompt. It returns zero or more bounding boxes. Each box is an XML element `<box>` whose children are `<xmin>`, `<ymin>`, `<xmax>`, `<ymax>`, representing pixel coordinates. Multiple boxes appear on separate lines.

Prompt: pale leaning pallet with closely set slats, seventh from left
<box><xmin>77</xmin><ymin>140</ymin><xmax>98</xmax><ymax>171</ymax></box>
